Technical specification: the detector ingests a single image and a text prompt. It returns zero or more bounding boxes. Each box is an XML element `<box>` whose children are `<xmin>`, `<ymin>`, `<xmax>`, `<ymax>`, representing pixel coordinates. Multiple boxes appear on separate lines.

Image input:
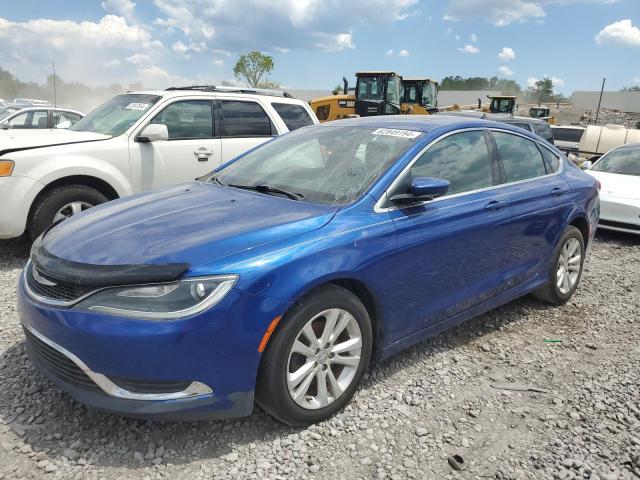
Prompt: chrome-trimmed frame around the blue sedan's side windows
<box><xmin>373</xmin><ymin>127</ymin><xmax>565</xmax><ymax>213</ymax></box>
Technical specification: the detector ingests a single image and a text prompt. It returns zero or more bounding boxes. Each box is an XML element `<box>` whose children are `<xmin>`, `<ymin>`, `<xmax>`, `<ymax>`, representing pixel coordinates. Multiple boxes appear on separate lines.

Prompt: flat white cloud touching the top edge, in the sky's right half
<box><xmin>444</xmin><ymin>0</ymin><xmax>616</xmax><ymax>26</ymax></box>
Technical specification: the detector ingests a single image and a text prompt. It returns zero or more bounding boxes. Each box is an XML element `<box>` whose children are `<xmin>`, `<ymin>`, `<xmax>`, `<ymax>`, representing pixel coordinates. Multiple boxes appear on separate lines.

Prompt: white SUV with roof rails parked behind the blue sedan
<box><xmin>0</xmin><ymin>86</ymin><xmax>318</xmax><ymax>238</ymax></box>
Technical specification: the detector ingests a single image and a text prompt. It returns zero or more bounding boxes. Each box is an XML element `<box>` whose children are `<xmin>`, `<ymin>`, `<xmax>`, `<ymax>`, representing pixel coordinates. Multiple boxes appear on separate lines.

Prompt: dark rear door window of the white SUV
<box><xmin>221</xmin><ymin>100</ymin><xmax>276</xmax><ymax>137</ymax></box>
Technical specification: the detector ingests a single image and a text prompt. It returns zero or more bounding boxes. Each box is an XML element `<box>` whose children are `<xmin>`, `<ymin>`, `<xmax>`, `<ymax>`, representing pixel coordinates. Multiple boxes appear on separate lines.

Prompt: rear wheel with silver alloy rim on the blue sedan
<box><xmin>533</xmin><ymin>225</ymin><xmax>585</xmax><ymax>305</ymax></box>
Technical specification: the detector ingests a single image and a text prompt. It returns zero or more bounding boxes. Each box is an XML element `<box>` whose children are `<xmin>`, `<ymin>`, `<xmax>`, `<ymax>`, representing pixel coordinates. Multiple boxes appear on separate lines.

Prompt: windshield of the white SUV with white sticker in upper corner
<box><xmin>69</xmin><ymin>94</ymin><xmax>160</xmax><ymax>137</ymax></box>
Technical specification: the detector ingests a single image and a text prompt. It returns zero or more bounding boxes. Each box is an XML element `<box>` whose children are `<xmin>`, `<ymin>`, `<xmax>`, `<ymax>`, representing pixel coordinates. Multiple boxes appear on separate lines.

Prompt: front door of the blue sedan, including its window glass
<box><xmin>380</xmin><ymin>130</ymin><xmax>509</xmax><ymax>342</ymax></box>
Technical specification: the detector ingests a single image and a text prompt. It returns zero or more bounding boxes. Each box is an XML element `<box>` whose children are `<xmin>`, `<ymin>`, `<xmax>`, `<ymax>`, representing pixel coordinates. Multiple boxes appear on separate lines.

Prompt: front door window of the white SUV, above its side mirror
<box><xmin>151</xmin><ymin>100</ymin><xmax>213</xmax><ymax>140</ymax></box>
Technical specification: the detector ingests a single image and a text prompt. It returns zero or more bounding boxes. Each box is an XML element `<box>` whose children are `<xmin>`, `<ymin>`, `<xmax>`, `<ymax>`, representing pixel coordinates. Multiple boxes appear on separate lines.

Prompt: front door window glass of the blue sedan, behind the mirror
<box><xmin>411</xmin><ymin>130</ymin><xmax>493</xmax><ymax>194</ymax></box>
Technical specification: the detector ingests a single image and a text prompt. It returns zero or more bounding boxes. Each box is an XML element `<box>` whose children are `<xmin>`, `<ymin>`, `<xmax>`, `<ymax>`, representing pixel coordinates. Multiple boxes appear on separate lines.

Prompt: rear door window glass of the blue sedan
<box><xmin>493</xmin><ymin>132</ymin><xmax>547</xmax><ymax>182</ymax></box>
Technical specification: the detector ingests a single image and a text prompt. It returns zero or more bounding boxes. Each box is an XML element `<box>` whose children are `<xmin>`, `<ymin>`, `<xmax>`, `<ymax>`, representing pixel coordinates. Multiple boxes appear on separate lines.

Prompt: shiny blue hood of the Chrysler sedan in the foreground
<box><xmin>41</xmin><ymin>182</ymin><xmax>339</xmax><ymax>267</ymax></box>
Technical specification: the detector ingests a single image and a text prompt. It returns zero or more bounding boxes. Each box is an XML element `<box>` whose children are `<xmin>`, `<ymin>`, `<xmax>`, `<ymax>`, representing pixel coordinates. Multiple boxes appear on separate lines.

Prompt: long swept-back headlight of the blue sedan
<box><xmin>73</xmin><ymin>275</ymin><xmax>238</xmax><ymax>320</ymax></box>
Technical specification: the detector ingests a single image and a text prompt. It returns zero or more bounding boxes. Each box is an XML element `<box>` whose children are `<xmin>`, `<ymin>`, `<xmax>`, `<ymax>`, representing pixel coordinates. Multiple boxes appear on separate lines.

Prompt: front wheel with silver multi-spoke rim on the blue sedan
<box><xmin>256</xmin><ymin>285</ymin><xmax>372</xmax><ymax>426</ymax></box>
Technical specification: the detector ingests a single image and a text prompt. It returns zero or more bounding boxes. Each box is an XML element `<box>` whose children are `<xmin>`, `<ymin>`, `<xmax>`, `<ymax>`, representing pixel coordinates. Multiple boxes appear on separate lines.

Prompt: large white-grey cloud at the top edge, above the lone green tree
<box><xmin>154</xmin><ymin>0</ymin><xmax>418</xmax><ymax>52</ymax></box>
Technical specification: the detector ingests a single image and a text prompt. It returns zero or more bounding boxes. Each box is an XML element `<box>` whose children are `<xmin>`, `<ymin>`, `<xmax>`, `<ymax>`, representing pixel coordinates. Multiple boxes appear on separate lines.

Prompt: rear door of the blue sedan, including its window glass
<box><xmin>491</xmin><ymin>130</ymin><xmax>570</xmax><ymax>290</ymax></box>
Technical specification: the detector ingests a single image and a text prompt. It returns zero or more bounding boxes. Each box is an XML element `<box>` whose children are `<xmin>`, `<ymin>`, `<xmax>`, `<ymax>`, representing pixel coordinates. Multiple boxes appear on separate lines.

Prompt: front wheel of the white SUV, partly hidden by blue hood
<box><xmin>28</xmin><ymin>185</ymin><xmax>109</xmax><ymax>240</ymax></box>
